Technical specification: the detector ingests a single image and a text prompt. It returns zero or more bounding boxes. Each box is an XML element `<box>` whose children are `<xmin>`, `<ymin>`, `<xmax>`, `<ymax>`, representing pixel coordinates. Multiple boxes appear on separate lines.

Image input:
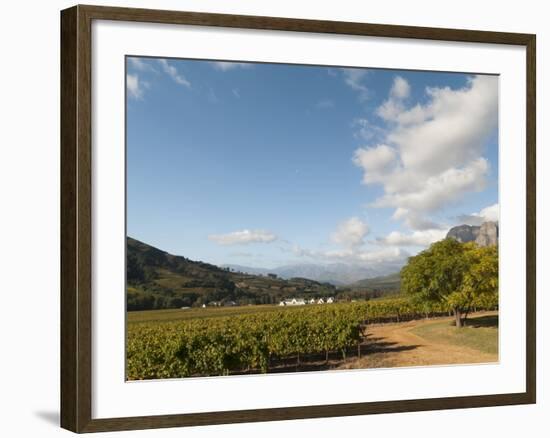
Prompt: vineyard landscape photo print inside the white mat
<box><xmin>126</xmin><ymin>56</ymin><xmax>499</xmax><ymax>380</ymax></box>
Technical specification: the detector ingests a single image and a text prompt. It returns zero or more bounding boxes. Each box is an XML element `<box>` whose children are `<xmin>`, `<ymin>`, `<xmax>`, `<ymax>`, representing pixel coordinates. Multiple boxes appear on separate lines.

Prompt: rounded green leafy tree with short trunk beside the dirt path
<box><xmin>401</xmin><ymin>239</ymin><xmax>498</xmax><ymax>327</ymax></box>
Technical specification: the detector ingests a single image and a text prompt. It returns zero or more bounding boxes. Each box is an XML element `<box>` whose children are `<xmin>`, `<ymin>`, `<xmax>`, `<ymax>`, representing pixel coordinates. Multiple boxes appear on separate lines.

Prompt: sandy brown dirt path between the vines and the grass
<box><xmin>341</xmin><ymin>312</ymin><xmax>498</xmax><ymax>368</ymax></box>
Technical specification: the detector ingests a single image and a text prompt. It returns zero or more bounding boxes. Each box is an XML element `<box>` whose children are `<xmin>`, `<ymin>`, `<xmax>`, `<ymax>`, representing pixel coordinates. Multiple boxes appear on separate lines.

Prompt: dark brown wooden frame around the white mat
<box><xmin>61</xmin><ymin>6</ymin><xmax>536</xmax><ymax>432</ymax></box>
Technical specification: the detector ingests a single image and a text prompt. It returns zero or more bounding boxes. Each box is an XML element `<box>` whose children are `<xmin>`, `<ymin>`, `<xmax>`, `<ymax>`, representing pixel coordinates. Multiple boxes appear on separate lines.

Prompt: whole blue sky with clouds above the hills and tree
<box><xmin>126</xmin><ymin>58</ymin><xmax>498</xmax><ymax>268</ymax></box>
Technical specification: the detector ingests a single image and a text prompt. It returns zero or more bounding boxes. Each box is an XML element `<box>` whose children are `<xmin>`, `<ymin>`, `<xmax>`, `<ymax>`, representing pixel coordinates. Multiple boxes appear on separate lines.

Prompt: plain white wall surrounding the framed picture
<box><xmin>0</xmin><ymin>0</ymin><xmax>550</xmax><ymax>438</ymax></box>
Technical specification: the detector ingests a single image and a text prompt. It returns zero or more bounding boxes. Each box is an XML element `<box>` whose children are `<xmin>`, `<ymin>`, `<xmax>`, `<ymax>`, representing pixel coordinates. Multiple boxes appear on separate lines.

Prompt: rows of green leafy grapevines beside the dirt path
<box><xmin>127</xmin><ymin>298</ymin><xmax>498</xmax><ymax>380</ymax></box>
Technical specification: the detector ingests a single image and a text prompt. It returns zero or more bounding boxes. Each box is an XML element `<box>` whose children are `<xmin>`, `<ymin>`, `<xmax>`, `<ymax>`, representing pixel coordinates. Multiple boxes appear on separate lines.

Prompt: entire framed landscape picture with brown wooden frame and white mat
<box><xmin>61</xmin><ymin>6</ymin><xmax>536</xmax><ymax>432</ymax></box>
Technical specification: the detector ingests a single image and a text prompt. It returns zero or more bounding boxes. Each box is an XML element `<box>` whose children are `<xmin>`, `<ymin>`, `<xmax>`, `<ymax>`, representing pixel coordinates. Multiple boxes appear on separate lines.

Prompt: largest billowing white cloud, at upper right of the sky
<box><xmin>353</xmin><ymin>76</ymin><xmax>498</xmax><ymax>230</ymax></box>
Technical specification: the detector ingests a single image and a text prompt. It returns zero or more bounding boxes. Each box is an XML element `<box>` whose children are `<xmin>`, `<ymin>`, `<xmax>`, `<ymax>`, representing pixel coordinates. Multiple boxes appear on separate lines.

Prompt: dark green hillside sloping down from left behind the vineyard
<box><xmin>126</xmin><ymin>237</ymin><xmax>335</xmax><ymax>310</ymax></box>
